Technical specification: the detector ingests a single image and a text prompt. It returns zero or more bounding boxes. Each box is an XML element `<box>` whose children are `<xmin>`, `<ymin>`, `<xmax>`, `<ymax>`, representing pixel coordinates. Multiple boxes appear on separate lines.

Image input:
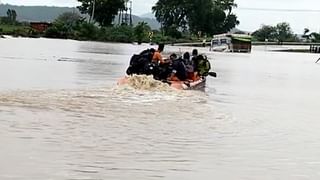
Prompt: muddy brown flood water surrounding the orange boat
<box><xmin>0</xmin><ymin>38</ymin><xmax>320</xmax><ymax>180</ymax></box>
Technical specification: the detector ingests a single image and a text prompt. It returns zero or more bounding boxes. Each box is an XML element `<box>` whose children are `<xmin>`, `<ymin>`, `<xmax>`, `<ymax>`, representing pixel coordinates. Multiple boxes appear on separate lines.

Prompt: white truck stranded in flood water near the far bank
<box><xmin>210</xmin><ymin>34</ymin><xmax>252</xmax><ymax>53</ymax></box>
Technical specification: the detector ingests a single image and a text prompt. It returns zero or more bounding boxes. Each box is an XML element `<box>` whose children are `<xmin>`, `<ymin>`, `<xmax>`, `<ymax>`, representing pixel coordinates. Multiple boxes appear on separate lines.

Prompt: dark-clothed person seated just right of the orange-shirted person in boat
<box><xmin>167</xmin><ymin>54</ymin><xmax>187</xmax><ymax>81</ymax></box>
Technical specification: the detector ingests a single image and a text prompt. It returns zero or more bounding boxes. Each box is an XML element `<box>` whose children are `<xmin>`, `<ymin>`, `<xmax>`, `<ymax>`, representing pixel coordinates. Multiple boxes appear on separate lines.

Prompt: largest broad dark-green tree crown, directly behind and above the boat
<box><xmin>152</xmin><ymin>0</ymin><xmax>239</xmax><ymax>35</ymax></box>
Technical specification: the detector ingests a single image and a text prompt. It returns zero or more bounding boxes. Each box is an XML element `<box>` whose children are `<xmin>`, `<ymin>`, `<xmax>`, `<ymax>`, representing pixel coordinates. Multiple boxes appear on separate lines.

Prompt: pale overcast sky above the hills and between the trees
<box><xmin>0</xmin><ymin>0</ymin><xmax>320</xmax><ymax>34</ymax></box>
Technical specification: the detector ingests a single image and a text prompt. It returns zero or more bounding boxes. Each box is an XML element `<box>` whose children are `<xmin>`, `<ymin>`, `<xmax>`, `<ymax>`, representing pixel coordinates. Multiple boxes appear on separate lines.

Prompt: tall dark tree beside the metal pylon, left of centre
<box><xmin>78</xmin><ymin>0</ymin><xmax>126</xmax><ymax>26</ymax></box>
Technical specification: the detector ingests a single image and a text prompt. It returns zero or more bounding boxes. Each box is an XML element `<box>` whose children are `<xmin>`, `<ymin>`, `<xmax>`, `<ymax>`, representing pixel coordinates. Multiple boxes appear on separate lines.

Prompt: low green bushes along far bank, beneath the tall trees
<box><xmin>0</xmin><ymin>9</ymin><xmax>205</xmax><ymax>43</ymax></box>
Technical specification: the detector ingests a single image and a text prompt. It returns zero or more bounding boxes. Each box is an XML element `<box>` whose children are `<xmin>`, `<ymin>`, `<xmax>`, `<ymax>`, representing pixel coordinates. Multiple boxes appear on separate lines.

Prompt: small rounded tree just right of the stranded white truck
<box><xmin>252</xmin><ymin>25</ymin><xmax>277</xmax><ymax>41</ymax></box>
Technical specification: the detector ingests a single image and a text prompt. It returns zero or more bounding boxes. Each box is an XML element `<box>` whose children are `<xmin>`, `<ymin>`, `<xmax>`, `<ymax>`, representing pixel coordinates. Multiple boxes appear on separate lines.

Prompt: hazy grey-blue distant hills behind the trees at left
<box><xmin>0</xmin><ymin>4</ymin><xmax>160</xmax><ymax>29</ymax></box>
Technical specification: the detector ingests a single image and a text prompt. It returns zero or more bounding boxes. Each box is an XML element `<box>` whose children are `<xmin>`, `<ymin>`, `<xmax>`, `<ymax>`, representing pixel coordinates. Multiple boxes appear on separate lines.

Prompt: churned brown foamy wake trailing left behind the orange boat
<box><xmin>0</xmin><ymin>81</ymin><xmax>207</xmax><ymax>114</ymax></box>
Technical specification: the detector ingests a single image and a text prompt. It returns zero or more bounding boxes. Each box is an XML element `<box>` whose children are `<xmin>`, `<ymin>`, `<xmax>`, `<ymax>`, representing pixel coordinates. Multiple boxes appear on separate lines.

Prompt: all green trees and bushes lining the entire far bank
<box><xmin>0</xmin><ymin>0</ymin><xmax>320</xmax><ymax>44</ymax></box>
